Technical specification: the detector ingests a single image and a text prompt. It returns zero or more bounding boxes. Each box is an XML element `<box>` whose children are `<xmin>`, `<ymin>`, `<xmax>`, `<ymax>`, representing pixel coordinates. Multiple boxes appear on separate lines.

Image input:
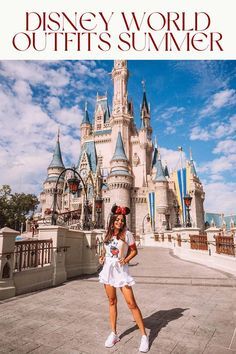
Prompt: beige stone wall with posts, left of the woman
<box><xmin>0</xmin><ymin>226</ymin><xmax>101</xmax><ymax>300</ymax></box>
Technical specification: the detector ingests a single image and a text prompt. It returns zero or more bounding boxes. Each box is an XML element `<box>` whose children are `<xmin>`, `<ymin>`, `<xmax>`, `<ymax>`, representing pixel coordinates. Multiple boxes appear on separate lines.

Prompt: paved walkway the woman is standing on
<box><xmin>0</xmin><ymin>248</ymin><xmax>236</xmax><ymax>354</ymax></box>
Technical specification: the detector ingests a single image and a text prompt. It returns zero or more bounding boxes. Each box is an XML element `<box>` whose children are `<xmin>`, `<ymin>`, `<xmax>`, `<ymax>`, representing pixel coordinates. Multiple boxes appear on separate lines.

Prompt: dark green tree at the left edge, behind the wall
<box><xmin>0</xmin><ymin>185</ymin><xmax>39</xmax><ymax>231</ymax></box>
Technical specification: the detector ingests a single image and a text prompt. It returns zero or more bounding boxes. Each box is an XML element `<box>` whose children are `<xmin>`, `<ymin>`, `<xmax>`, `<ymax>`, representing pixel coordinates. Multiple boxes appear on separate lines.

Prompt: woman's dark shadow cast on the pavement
<box><xmin>120</xmin><ymin>308</ymin><xmax>188</xmax><ymax>347</ymax></box>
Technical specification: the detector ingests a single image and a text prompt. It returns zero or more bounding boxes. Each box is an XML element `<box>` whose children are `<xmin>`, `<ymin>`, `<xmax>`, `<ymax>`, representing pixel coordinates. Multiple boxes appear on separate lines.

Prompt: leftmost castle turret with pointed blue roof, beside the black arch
<box><xmin>40</xmin><ymin>133</ymin><xmax>65</xmax><ymax>215</ymax></box>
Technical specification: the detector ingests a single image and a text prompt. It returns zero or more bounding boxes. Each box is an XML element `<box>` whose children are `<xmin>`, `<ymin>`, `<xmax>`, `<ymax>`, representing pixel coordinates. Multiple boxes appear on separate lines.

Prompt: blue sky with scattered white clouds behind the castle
<box><xmin>0</xmin><ymin>60</ymin><xmax>236</xmax><ymax>214</ymax></box>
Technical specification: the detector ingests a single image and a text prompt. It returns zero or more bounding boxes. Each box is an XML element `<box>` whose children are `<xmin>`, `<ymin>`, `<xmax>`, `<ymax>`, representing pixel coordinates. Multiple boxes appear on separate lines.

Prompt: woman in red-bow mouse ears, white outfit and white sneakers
<box><xmin>99</xmin><ymin>205</ymin><xmax>149</xmax><ymax>353</ymax></box>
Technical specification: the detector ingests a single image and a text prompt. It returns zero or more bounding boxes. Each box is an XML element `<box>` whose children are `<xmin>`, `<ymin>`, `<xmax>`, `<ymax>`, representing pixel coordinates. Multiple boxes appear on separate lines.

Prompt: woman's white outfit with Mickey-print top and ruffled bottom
<box><xmin>99</xmin><ymin>231</ymin><xmax>135</xmax><ymax>288</ymax></box>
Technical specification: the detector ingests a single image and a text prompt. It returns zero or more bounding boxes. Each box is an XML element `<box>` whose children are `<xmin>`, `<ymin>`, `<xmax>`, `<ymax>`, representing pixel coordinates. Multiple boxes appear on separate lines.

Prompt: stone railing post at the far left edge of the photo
<box><xmin>0</xmin><ymin>227</ymin><xmax>20</xmax><ymax>300</ymax></box>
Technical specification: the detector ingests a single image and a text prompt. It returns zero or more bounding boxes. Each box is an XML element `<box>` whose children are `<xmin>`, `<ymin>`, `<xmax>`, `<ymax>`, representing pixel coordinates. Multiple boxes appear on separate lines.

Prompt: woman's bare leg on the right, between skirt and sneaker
<box><xmin>121</xmin><ymin>286</ymin><xmax>147</xmax><ymax>336</ymax></box>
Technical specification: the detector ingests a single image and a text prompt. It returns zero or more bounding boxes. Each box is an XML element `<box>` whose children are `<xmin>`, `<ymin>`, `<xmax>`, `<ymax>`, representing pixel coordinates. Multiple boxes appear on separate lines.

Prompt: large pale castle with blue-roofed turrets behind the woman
<box><xmin>40</xmin><ymin>60</ymin><xmax>205</xmax><ymax>233</ymax></box>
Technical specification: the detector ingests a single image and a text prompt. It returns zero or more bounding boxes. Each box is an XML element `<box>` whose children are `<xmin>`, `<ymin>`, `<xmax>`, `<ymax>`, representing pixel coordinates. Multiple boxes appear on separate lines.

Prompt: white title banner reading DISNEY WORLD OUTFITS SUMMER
<box><xmin>0</xmin><ymin>0</ymin><xmax>236</xmax><ymax>60</ymax></box>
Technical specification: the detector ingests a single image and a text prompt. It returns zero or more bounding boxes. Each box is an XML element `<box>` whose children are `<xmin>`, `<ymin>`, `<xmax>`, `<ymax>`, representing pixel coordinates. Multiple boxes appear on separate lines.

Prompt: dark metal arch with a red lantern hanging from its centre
<box><xmin>51</xmin><ymin>168</ymin><xmax>90</xmax><ymax>230</ymax></box>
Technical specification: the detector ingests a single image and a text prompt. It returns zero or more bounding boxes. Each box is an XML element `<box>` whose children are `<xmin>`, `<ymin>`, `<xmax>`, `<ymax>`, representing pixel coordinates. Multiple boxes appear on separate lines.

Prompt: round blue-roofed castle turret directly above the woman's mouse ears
<box><xmin>107</xmin><ymin>132</ymin><xmax>133</xmax><ymax>227</ymax></box>
